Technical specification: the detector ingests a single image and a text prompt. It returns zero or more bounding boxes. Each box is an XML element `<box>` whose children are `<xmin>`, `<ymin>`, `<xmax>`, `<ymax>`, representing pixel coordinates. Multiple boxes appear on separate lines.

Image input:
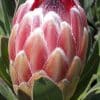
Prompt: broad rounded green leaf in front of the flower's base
<box><xmin>33</xmin><ymin>77</ymin><xmax>63</xmax><ymax>100</ymax></box>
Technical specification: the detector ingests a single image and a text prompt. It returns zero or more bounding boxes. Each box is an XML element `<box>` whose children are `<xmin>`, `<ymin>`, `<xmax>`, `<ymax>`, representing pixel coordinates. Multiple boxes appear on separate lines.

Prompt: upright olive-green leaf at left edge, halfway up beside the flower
<box><xmin>0</xmin><ymin>36</ymin><xmax>11</xmax><ymax>86</ymax></box>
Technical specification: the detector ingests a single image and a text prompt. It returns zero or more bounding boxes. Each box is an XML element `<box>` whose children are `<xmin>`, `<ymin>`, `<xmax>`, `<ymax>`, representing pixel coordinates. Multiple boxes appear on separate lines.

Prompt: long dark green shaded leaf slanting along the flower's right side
<box><xmin>72</xmin><ymin>41</ymin><xmax>100</xmax><ymax>100</ymax></box>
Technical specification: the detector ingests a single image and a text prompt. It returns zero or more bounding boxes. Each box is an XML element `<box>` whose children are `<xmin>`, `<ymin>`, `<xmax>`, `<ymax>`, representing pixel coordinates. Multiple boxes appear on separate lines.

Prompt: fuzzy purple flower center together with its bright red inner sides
<box><xmin>31</xmin><ymin>0</ymin><xmax>75</xmax><ymax>21</ymax></box>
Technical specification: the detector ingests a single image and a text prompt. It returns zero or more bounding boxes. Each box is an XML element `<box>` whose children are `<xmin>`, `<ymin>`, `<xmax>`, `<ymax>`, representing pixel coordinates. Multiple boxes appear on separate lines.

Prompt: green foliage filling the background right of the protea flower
<box><xmin>72</xmin><ymin>0</ymin><xmax>100</xmax><ymax>100</ymax></box>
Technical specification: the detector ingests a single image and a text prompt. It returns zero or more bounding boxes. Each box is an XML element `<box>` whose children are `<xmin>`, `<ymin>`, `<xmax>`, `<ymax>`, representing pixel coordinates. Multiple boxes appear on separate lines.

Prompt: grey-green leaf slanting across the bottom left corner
<box><xmin>0</xmin><ymin>79</ymin><xmax>17</xmax><ymax>100</ymax></box>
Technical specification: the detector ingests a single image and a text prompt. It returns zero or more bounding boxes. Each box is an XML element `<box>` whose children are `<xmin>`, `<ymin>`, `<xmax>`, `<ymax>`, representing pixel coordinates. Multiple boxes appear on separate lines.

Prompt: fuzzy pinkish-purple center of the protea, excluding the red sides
<box><xmin>41</xmin><ymin>0</ymin><xmax>66</xmax><ymax>20</ymax></box>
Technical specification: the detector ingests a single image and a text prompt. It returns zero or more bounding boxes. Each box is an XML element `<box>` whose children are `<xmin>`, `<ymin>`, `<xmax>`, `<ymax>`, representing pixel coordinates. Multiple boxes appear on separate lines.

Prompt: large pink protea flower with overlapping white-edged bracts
<box><xmin>9</xmin><ymin>0</ymin><xmax>88</xmax><ymax>99</ymax></box>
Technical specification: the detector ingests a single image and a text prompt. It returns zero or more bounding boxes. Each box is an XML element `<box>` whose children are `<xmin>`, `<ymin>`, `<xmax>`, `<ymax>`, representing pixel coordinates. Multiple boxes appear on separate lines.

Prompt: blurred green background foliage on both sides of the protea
<box><xmin>0</xmin><ymin>0</ymin><xmax>100</xmax><ymax>100</ymax></box>
